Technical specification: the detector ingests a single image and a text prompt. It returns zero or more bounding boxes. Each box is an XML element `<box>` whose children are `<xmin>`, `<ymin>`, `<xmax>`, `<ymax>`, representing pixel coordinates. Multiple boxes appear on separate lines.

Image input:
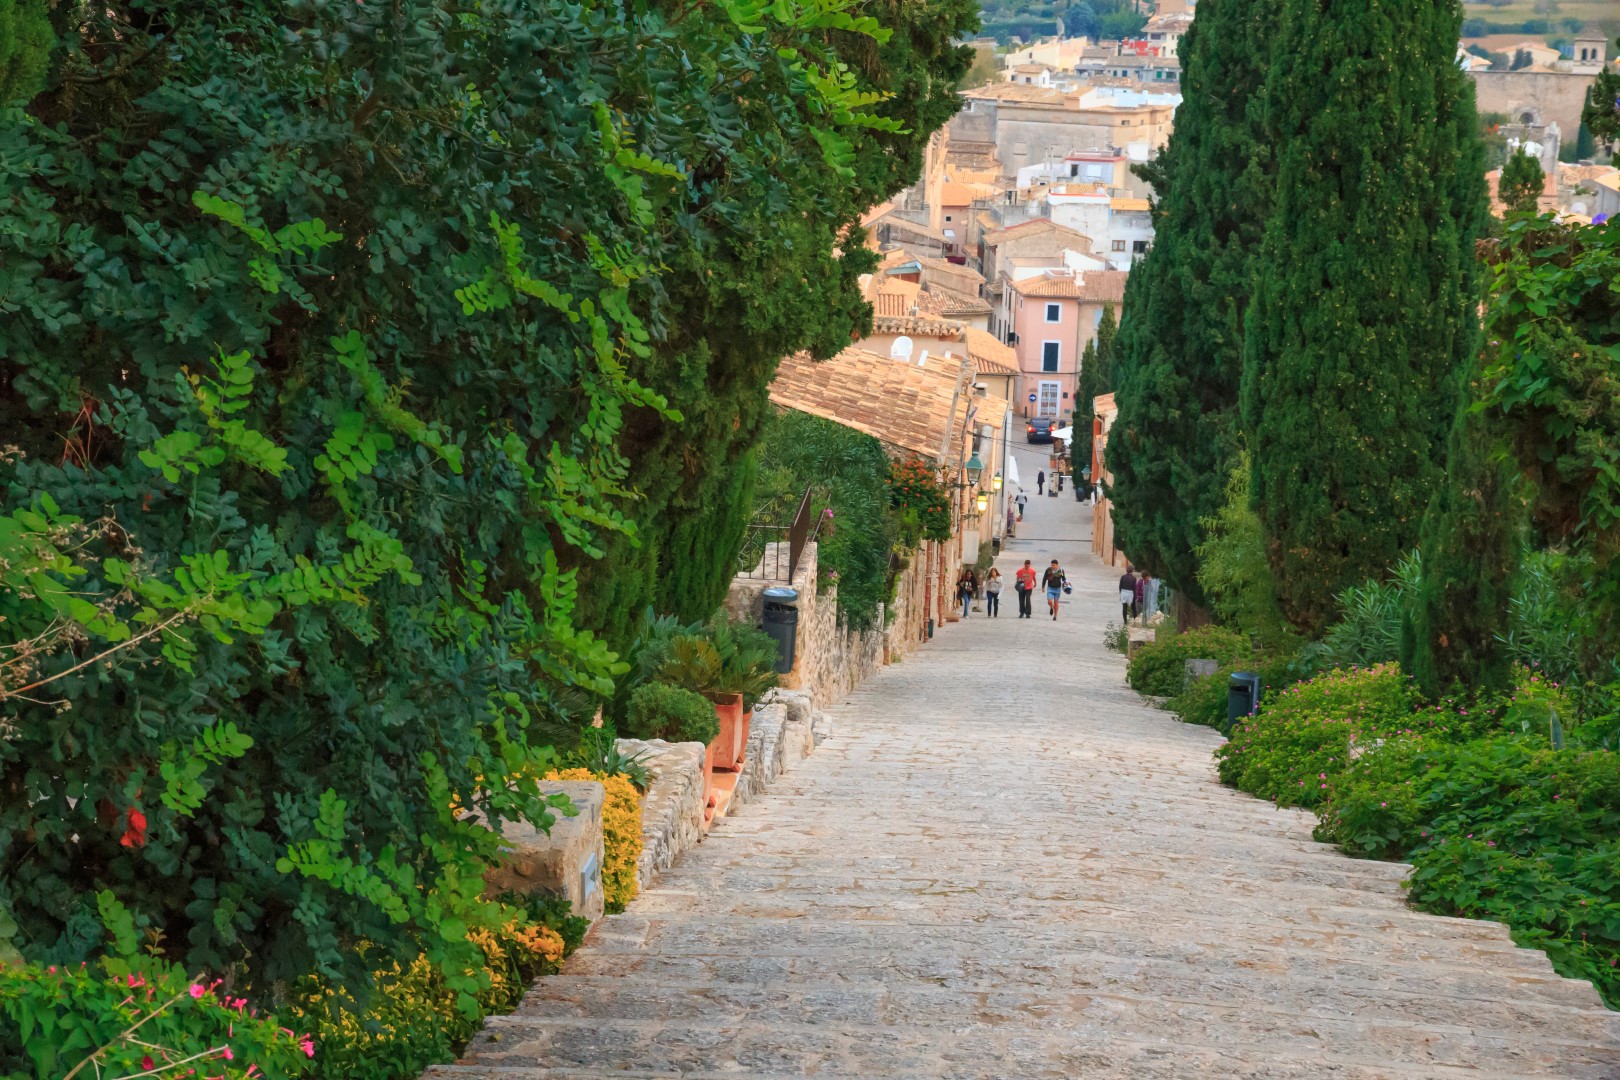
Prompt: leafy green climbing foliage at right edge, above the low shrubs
<box><xmin>1474</xmin><ymin>219</ymin><xmax>1620</xmax><ymax>677</ymax></box>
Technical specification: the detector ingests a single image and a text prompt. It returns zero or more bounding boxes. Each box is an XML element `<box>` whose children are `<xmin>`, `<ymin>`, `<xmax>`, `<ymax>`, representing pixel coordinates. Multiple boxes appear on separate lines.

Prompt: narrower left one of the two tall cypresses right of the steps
<box><xmin>1108</xmin><ymin>0</ymin><xmax>1278</xmax><ymax>604</ymax></box>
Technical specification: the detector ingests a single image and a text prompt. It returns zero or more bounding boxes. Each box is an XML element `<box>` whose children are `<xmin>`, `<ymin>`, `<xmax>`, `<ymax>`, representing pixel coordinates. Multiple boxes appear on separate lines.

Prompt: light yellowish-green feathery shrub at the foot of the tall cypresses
<box><xmin>1194</xmin><ymin>452</ymin><xmax>1291</xmax><ymax>648</ymax></box>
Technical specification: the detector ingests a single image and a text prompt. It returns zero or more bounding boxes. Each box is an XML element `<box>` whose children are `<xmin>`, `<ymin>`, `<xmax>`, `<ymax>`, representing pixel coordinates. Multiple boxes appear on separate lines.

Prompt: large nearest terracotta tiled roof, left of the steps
<box><xmin>771</xmin><ymin>348</ymin><xmax>969</xmax><ymax>461</ymax></box>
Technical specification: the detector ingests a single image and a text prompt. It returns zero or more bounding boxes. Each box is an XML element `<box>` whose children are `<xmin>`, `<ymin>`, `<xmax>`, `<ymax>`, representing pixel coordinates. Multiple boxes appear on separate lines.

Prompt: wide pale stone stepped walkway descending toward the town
<box><xmin>429</xmin><ymin>463</ymin><xmax>1620</xmax><ymax>1080</ymax></box>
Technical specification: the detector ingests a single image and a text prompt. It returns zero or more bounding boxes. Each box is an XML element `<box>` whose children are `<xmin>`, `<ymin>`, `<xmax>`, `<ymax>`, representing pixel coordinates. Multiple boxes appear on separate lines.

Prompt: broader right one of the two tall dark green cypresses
<box><xmin>1243</xmin><ymin>0</ymin><xmax>1486</xmax><ymax>631</ymax></box>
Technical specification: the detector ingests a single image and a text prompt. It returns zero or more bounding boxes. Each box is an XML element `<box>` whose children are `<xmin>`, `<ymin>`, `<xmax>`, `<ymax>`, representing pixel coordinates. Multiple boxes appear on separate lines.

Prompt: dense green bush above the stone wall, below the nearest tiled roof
<box><xmin>755</xmin><ymin>411</ymin><xmax>906</xmax><ymax>630</ymax></box>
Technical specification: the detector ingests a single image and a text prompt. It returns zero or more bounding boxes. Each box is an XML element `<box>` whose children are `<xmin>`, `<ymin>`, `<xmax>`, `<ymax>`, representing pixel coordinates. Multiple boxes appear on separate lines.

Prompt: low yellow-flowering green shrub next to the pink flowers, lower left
<box><xmin>285</xmin><ymin>897</ymin><xmax>590</xmax><ymax>1080</ymax></box>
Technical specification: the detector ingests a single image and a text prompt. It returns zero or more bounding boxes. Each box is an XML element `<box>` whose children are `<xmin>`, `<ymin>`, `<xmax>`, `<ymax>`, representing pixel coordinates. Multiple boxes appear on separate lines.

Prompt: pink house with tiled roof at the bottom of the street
<box><xmin>1009</xmin><ymin>270</ymin><xmax>1126</xmax><ymax>419</ymax></box>
